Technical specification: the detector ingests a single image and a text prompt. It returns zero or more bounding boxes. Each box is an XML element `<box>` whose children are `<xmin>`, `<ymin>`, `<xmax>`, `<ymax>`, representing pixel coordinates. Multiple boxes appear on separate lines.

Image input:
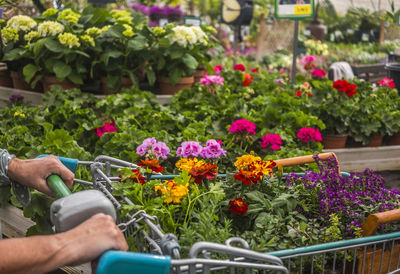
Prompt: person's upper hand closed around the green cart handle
<box><xmin>8</xmin><ymin>155</ymin><xmax>74</xmax><ymax>196</ymax></box>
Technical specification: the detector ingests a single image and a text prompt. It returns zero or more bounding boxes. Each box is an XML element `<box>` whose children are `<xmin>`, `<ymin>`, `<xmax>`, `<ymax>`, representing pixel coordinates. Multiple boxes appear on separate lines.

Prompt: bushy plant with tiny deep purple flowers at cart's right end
<box><xmin>286</xmin><ymin>156</ymin><xmax>400</xmax><ymax>237</ymax></box>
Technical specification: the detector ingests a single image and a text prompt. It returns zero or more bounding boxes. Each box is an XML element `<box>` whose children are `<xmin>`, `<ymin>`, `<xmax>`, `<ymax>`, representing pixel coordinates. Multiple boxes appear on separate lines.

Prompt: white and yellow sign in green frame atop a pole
<box><xmin>275</xmin><ymin>0</ymin><xmax>314</xmax><ymax>19</ymax></box>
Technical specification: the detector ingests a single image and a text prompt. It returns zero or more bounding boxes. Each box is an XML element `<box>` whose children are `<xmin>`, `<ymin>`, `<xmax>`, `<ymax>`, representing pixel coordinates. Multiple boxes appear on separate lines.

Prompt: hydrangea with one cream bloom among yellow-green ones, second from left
<box><xmin>23</xmin><ymin>9</ymin><xmax>94</xmax><ymax>91</ymax></box>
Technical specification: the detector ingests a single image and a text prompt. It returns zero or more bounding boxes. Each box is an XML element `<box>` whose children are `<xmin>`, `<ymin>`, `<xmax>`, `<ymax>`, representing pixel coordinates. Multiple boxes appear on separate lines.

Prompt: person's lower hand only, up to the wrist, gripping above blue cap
<box><xmin>57</xmin><ymin>213</ymin><xmax>128</xmax><ymax>265</ymax></box>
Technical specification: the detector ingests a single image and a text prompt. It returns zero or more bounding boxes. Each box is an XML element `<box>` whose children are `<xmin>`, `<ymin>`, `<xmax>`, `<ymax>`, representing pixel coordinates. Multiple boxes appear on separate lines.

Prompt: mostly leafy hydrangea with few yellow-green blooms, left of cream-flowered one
<box><xmin>88</xmin><ymin>11</ymin><xmax>151</xmax><ymax>93</ymax></box>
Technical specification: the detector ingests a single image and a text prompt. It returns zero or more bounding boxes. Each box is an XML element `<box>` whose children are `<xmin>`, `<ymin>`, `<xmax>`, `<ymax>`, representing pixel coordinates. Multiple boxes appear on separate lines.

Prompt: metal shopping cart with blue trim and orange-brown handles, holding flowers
<box><xmin>44</xmin><ymin>153</ymin><xmax>400</xmax><ymax>274</ymax></box>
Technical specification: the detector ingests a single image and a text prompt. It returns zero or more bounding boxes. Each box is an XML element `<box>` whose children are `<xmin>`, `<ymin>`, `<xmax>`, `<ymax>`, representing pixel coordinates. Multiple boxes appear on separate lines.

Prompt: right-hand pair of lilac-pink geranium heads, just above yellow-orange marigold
<box><xmin>176</xmin><ymin>139</ymin><xmax>226</xmax><ymax>159</ymax></box>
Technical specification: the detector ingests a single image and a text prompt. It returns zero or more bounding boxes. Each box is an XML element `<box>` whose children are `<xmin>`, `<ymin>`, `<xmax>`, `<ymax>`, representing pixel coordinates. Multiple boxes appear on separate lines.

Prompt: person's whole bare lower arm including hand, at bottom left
<box><xmin>0</xmin><ymin>214</ymin><xmax>128</xmax><ymax>273</ymax></box>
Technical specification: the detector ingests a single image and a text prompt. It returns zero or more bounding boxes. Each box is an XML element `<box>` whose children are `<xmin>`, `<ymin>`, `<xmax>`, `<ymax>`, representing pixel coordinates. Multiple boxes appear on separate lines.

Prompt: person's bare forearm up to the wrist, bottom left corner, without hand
<box><xmin>0</xmin><ymin>234</ymin><xmax>73</xmax><ymax>273</ymax></box>
